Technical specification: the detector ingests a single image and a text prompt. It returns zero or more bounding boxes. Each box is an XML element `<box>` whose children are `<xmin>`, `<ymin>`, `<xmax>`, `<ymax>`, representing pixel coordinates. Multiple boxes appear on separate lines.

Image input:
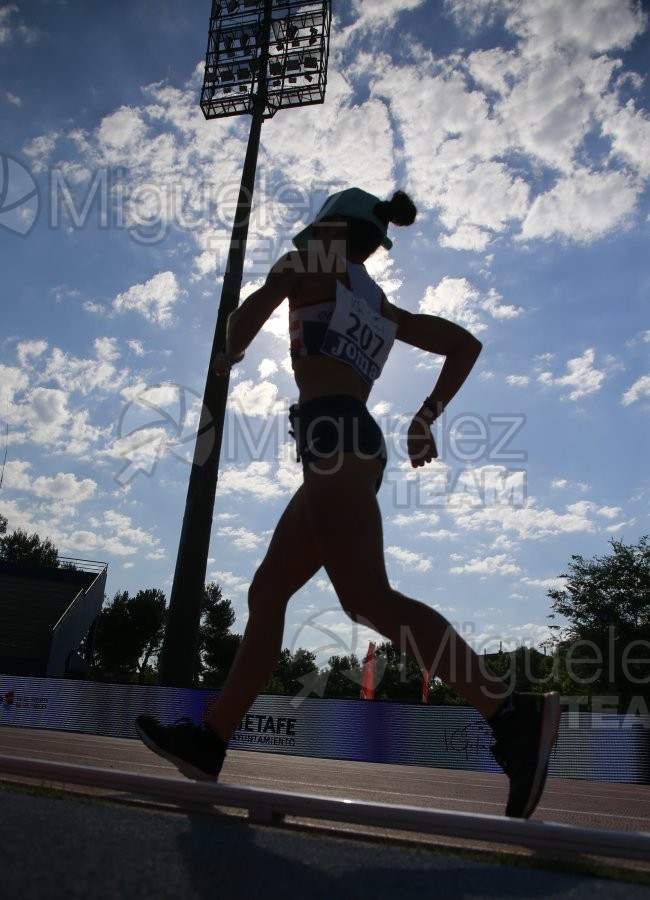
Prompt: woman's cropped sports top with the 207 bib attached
<box><xmin>289</xmin><ymin>261</ymin><xmax>397</xmax><ymax>385</ymax></box>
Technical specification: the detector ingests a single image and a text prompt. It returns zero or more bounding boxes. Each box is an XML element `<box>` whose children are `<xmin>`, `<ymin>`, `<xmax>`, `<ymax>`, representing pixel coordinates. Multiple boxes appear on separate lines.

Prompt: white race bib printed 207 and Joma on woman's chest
<box><xmin>321</xmin><ymin>284</ymin><xmax>397</xmax><ymax>384</ymax></box>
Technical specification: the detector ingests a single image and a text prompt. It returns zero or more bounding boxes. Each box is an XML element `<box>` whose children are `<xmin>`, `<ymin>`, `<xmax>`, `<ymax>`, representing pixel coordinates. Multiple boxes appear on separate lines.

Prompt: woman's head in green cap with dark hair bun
<box><xmin>293</xmin><ymin>188</ymin><xmax>417</xmax><ymax>262</ymax></box>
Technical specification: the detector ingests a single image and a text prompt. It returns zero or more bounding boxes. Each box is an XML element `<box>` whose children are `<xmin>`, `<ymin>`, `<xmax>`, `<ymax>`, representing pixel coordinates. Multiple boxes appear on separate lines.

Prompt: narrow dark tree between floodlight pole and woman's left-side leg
<box><xmin>199</xmin><ymin>583</ymin><xmax>242</xmax><ymax>688</ymax></box>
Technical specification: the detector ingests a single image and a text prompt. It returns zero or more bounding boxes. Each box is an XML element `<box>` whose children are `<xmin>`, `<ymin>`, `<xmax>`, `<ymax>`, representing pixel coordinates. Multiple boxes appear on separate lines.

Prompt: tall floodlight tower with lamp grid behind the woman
<box><xmin>160</xmin><ymin>0</ymin><xmax>332</xmax><ymax>687</ymax></box>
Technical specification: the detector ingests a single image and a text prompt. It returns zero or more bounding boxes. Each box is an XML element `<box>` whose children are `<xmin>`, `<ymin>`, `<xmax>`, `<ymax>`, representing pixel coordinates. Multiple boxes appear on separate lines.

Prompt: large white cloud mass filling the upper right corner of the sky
<box><xmin>368</xmin><ymin>0</ymin><xmax>650</xmax><ymax>252</ymax></box>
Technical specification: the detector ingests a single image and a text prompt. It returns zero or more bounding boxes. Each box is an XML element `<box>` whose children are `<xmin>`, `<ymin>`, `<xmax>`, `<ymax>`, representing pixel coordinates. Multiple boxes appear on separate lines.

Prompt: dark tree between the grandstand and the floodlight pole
<box><xmin>94</xmin><ymin>588</ymin><xmax>166</xmax><ymax>684</ymax></box>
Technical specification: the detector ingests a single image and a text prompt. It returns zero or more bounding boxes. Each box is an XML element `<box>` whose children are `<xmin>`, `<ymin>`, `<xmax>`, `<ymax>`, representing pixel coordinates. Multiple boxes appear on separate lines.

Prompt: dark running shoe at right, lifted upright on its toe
<box><xmin>490</xmin><ymin>691</ymin><xmax>560</xmax><ymax>819</ymax></box>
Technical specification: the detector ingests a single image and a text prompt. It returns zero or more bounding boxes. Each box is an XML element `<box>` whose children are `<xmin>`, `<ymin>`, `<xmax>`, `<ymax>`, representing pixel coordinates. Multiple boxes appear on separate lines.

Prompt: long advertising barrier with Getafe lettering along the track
<box><xmin>0</xmin><ymin>675</ymin><xmax>650</xmax><ymax>784</ymax></box>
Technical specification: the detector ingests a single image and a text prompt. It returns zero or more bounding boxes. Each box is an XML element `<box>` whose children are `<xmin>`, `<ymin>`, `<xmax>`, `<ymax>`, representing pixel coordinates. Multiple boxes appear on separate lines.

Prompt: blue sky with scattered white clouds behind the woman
<box><xmin>0</xmin><ymin>0</ymin><xmax>650</xmax><ymax>658</ymax></box>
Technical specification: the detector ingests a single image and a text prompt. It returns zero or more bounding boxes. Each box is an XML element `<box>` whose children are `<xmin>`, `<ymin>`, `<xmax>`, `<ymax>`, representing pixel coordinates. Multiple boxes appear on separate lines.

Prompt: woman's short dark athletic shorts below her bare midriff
<box><xmin>289</xmin><ymin>394</ymin><xmax>387</xmax><ymax>490</ymax></box>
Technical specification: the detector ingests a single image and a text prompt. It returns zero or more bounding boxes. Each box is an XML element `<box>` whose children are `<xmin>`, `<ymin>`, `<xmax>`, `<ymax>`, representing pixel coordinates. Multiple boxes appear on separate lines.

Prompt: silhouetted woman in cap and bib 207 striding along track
<box><xmin>136</xmin><ymin>187</ymin><xmax>560</xmax><ymax>818</ymax></box>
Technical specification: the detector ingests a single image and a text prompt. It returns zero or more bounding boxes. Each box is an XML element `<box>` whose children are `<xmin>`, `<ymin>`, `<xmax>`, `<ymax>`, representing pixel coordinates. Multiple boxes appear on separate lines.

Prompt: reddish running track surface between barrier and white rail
<box><xmin>0</xmin><ymin>727</ymin><xmax>650</xmax><ymax>872</ymax></box>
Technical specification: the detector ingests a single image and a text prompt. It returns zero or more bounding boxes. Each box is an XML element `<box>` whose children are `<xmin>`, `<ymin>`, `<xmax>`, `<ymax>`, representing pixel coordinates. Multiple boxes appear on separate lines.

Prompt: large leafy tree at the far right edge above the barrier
<box><xmin>548</xmin><ymin>536</ymin><xmax>650</xmax><ymax>712</ymax></box>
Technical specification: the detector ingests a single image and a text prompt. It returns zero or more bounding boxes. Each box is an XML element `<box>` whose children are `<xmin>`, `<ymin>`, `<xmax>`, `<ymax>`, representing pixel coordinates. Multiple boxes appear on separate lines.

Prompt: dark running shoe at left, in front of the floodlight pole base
<box><xmin>135</xmin><ymin>716</ymin><xmax>227</xmax><ymax>781</ymax></box>
